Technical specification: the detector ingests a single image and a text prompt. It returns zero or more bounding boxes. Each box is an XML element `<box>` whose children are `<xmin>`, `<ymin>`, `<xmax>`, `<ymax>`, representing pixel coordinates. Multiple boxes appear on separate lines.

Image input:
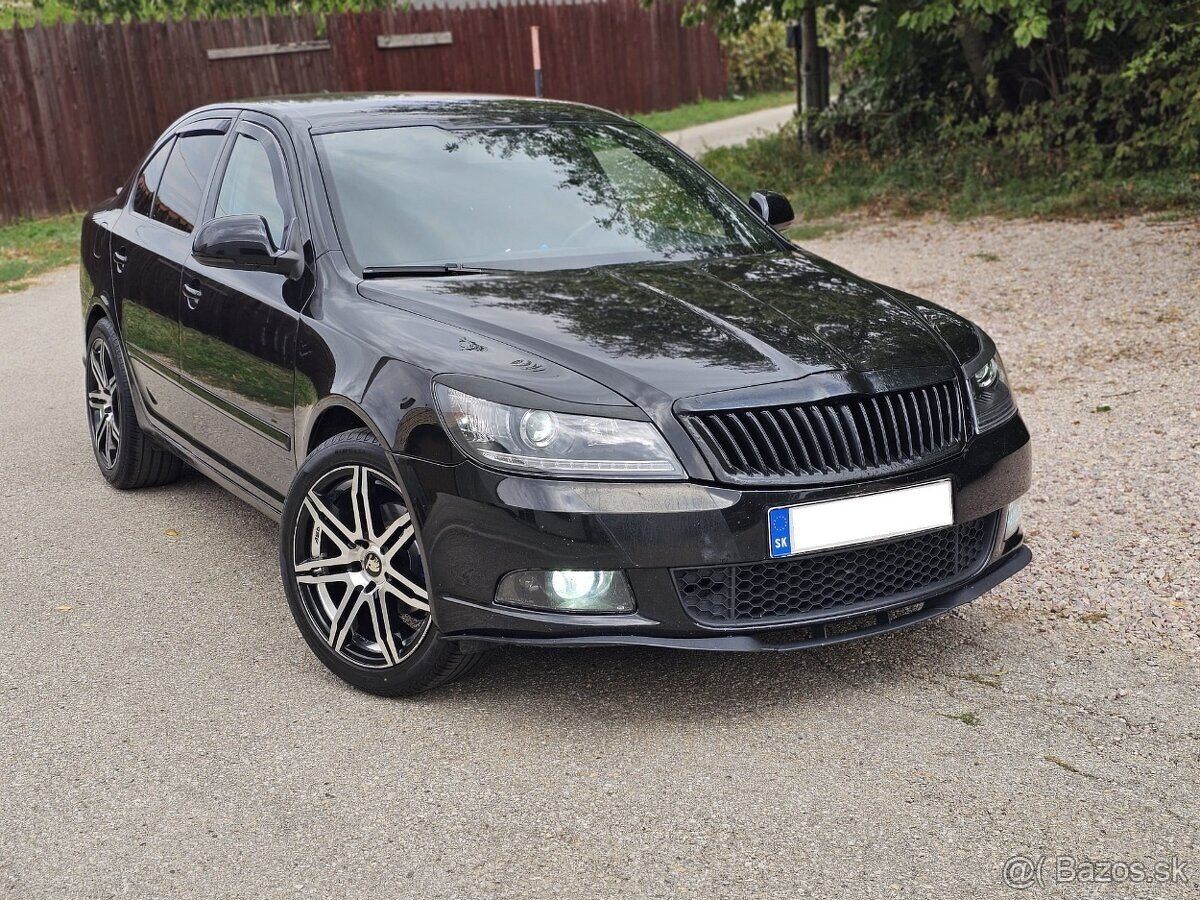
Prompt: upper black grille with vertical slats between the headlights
<box><xmin>682</xmin><ymin>382</ymin><xmax>966</xmax><ymax>481</ymax></box>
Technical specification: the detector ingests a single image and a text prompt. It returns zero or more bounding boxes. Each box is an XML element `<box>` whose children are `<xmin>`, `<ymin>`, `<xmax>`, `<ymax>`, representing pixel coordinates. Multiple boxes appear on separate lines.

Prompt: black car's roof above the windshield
<box><xmin>187</xmin><ymin>94</ymin><xmax>625</xmax><ymax>132</ymax></box>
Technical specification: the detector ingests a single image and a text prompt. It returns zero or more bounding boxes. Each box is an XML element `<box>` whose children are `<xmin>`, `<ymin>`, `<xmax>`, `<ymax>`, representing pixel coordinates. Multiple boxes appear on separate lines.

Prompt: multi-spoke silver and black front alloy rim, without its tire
<box><xmin>292</xmin><ymin>464</ymin><xmax>430</xmax><ymax>668</ymax></box>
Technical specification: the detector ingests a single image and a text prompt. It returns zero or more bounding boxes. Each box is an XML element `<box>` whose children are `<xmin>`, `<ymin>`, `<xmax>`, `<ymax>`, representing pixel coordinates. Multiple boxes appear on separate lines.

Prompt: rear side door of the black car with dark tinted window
<box><xmin>109</xmin><ymin>118</ymin><xmax>230</xmax><ymax>425</ymax></box>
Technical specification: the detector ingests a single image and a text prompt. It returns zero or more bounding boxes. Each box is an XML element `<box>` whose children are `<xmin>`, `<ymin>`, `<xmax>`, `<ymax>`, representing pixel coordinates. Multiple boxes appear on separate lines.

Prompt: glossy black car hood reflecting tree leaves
<box><xmin>359</xmin><ymin>252</ymin><xmax>954</xmax><ymax>403</ymax></box>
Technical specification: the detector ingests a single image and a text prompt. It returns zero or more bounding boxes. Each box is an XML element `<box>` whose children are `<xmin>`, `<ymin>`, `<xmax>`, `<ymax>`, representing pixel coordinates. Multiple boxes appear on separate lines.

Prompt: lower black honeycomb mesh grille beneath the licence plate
<box><xmin>672</xmin><ymin>515</ymin><xmax>996</xmax><ymax>625</ymax></box>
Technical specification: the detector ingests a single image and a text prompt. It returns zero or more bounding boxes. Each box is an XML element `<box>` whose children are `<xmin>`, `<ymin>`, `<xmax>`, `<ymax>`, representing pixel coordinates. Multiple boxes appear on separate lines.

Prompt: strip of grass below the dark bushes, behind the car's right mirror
<box><xmin>701</xmin><ymin>127</ymin><xmax>1200</xmax><ymax>225</ymax></box>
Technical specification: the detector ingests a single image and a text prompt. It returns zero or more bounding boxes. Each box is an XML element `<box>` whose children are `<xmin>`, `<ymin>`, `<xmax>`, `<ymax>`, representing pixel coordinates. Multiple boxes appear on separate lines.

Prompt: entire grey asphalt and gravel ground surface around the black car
<box><xmin>0</xmin><ymin>214</ymin><xmax>1200</xmax><ymax>900</ymax></box>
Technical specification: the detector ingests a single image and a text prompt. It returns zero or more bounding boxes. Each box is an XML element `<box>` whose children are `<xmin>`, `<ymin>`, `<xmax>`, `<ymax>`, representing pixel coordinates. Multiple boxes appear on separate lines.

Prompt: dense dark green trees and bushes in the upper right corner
<box><xmin>688</xmin><ymin>0</ymin><xmax>1200</xmax><ymax>178</ymax></box>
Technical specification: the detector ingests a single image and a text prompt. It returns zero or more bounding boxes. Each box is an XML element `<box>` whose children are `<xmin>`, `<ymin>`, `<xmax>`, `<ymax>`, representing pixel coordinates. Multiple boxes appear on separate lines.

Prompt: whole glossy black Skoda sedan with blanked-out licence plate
<box><xmin>82</xmin><ymin>96</ymin><xmax>1031</xmax><ymax>695</ymax></box>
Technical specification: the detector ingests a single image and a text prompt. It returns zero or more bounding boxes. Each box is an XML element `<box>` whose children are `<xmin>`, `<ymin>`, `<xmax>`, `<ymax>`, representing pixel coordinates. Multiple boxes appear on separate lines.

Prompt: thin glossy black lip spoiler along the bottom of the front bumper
<box><xmin>445</xmin><ymin>545</ymin><xmax>1033</xmax><ymax>653</ymax></box>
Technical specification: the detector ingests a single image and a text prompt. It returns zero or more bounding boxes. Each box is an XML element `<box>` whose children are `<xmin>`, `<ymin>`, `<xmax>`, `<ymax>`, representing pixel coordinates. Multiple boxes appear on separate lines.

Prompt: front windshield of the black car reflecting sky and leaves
<box><xmin>316</xmin><ymin>124</ymin><xmax>779</xmax><ymax>271</ymax></box>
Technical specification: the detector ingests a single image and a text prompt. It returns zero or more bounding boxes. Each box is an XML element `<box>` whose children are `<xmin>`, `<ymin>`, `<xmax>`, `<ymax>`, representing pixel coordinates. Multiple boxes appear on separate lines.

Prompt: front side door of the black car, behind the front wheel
<box><xmin>180</xmin><ymin>120</ymin><xmax>308</xmax><ymax>498</ymax></box>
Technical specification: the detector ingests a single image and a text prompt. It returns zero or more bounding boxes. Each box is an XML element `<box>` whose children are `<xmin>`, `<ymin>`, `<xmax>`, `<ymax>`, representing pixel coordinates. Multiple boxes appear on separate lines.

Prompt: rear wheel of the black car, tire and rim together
<box><xmin>84</xmin><ymin>318</ymin><xmax>184</xmax><ymax>491</ymax></box>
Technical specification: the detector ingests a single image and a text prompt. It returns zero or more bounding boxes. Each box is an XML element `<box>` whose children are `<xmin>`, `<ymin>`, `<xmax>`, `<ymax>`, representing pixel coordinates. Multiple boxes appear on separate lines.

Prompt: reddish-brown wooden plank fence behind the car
<box><xmin>0</xmin><ymin>0</ymin><xmax>725</xmax><ymax>223</ymax></box>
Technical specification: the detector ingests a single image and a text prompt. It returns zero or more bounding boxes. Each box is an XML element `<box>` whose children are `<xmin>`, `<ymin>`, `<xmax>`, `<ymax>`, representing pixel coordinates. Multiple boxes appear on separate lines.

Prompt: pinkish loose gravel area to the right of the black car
<box><xmin>808</xmin><ymin>220</ymin><xmax>1200</xmax><ymax>653</ymax></box>
